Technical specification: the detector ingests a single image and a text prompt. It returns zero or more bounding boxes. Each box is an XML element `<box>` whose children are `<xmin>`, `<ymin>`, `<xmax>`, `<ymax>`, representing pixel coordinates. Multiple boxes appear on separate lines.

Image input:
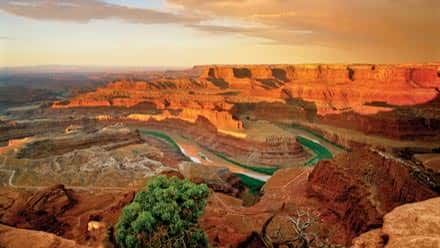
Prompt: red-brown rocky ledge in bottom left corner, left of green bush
<box><xmin>0</xmin><ymin>185</ymin><xmax>134</xmax><ymax>248</ymax></box>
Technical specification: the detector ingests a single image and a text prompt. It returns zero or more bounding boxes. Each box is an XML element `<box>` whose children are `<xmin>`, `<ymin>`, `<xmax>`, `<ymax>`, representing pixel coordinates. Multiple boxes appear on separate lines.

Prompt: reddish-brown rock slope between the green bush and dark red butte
<box><xmin>199</xmin><ymin>168</ymin><xmax>317</xmax><ymax>247</ymax></box>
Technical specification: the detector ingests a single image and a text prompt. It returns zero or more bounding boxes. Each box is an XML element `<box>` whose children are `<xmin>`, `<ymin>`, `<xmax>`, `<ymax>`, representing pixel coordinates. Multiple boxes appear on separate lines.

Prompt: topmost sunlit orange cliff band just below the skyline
<box><xmin>200</xmin><ymin>64</ymin><xmax>440</xmax><ymax>87</ymax></box>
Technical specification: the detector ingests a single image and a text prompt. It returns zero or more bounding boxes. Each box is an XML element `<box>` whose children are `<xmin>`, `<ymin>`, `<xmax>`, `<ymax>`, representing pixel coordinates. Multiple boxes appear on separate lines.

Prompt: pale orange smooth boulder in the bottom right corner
<box><xmin>353</xmin><ymin>197</ymin><xmax>440</xmax><ymax>248</ymax></box>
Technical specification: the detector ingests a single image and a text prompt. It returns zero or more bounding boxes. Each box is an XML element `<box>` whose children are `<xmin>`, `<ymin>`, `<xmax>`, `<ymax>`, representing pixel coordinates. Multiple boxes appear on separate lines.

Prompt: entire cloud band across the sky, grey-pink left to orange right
<box><xmin>0</xmin><ymin>0</ymin><xmax>440</xmax><ymax>61</ymax></box>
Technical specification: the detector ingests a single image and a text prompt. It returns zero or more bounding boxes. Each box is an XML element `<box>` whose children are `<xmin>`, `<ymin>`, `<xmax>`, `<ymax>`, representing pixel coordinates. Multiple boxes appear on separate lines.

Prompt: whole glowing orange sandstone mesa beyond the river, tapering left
<box><xmin>52</xmin><ymin>64</ymin><xmax>440</xmax><ymax>139</ymax></box>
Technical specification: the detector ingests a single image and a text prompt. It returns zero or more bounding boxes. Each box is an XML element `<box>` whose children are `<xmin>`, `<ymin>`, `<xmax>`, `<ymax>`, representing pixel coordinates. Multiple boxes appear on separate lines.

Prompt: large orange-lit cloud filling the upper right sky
<box><xmin>169</xmin><ymin>0</ymin><xmax>440</xmax><ymax>59</ymax></box>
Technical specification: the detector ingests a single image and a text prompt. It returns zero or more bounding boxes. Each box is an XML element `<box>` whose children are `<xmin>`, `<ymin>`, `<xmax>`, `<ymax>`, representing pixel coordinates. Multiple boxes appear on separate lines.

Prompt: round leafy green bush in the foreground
<box><xmin>115</xmin><ymin>176</ymin><xmax>209</xmax><ymax>248</ymax></box>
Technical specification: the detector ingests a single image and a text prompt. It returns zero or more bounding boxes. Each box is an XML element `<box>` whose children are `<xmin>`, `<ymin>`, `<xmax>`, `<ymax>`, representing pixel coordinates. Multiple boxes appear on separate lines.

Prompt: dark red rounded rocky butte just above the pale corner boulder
<box><xmin>309</xmin><ymin>149</ymin><xmax>439</xmax><ymax>242</ymax></box>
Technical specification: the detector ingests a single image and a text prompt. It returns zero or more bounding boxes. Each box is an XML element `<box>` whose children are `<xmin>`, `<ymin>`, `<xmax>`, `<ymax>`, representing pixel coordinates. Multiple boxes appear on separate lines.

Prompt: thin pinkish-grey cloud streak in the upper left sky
<box><xmin>0</xmin><ymin>0</ymin><xmax>199</xmax><ymax>24</ymax></box>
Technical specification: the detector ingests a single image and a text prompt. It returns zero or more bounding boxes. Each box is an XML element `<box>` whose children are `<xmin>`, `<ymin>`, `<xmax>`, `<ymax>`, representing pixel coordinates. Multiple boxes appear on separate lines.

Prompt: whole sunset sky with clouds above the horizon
<box><xmin>0</xmin><ymin>0</ymin><xmax>440</xmax><ymax>67</ymax></box>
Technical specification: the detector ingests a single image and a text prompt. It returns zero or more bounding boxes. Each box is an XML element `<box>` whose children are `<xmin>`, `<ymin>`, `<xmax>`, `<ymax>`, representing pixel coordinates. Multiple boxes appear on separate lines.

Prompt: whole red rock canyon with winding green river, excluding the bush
<box><xmin>0</xmin><ymin>63</ymin><xmax>440</xmax><ymax>248</ymax></box>
